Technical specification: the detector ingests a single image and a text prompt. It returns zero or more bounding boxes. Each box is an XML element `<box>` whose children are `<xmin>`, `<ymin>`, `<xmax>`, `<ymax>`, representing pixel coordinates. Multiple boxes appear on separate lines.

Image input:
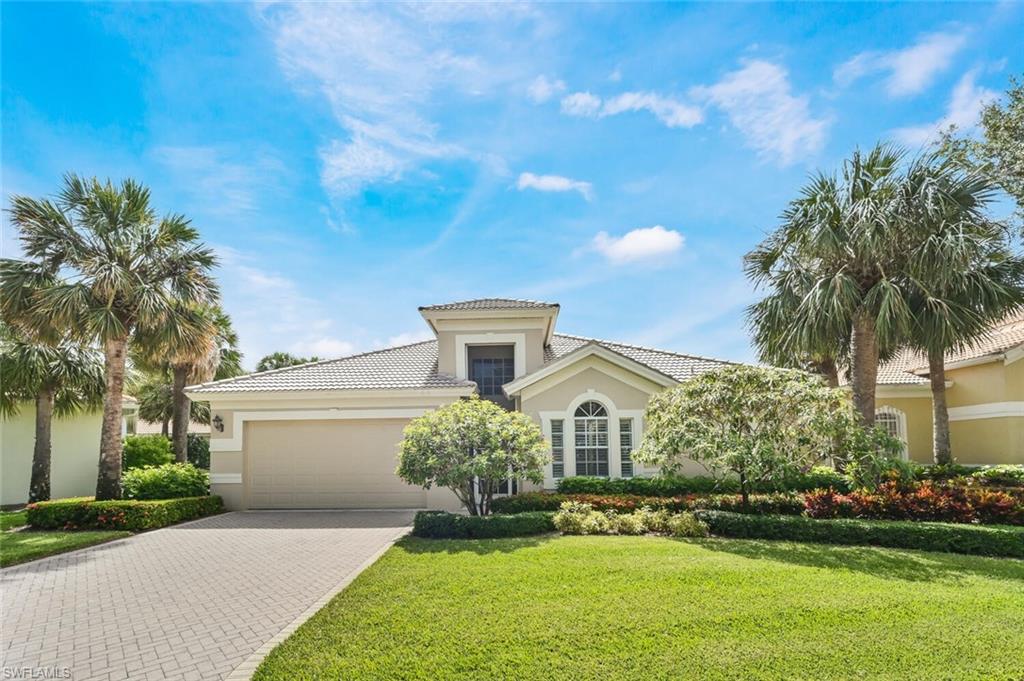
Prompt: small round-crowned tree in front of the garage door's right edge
<box><xmin>396</xmin><ymin>396</ymin><xmax>549</xmax><ymax>515</ymax></box>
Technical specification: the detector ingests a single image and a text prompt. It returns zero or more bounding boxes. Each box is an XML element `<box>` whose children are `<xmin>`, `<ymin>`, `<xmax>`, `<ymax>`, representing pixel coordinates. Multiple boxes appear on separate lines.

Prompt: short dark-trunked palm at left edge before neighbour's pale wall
<box><xmin>0</xmin><ymin>322</ymin><xmax>103</xmax><ymax>503</ymax></box>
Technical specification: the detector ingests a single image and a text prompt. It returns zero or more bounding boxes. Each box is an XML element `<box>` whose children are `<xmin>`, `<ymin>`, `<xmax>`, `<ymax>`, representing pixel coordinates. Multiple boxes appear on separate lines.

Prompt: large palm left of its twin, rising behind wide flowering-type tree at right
<box><xmin>746</xmin><ymin>144</ymin><xmax>910</xmax><ymax>426</ymax></box>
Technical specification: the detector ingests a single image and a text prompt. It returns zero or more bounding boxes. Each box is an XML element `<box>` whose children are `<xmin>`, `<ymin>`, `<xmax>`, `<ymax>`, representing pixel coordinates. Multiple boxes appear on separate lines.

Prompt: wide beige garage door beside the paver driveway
<box><xmin>245</xmin><ymin>419</ymin><xmax>426</xmax><ymax>508</ymax></box>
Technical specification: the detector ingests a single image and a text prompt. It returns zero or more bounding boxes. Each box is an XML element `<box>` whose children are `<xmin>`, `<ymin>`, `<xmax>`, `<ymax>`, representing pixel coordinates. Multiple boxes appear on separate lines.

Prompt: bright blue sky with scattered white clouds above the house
<box><xmin>2</xmin><ymin>2</ymin><xmax>1024</xmax><ymax>367</ymax></box>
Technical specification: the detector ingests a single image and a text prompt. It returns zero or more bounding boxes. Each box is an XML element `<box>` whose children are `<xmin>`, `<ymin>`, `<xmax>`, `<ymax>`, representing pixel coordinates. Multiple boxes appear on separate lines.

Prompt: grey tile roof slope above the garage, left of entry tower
<box><xmin>189</xmin><ymin>340</ymin><xmax>473</xmax><ymax>392</ymax></box>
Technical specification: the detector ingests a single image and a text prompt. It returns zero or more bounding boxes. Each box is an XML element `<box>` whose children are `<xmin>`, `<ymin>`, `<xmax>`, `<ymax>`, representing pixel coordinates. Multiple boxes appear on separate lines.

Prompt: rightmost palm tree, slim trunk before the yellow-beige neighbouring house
<box><xmin>902</xmin><ymin>154</ymin><xmax>1024</xmax><ymax>464</ymax></box>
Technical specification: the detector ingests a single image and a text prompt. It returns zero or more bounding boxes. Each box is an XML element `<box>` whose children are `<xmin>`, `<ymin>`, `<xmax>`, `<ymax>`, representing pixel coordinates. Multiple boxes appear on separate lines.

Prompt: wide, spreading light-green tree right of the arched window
<box><xmin>633</xmin><ymin>367</ymin><xmax>859</xmax><ymax>504</ymax></box>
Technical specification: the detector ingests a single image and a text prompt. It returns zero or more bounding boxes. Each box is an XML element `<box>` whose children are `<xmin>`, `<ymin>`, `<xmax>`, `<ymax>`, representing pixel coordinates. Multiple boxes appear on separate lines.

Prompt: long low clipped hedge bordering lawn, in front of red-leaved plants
<box><xmin>694</xmin><ymin>511</ymin><xmax>1024</xmax><ymax>558</ymax></box>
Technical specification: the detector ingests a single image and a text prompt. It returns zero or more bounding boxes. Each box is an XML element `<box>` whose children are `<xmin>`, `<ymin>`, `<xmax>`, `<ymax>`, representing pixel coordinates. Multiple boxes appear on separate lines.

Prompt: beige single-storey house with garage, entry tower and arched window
<box><xmin>187</xmin><ymin>298</ymin><xmax>729</xmax><ymax>509</ymax></box>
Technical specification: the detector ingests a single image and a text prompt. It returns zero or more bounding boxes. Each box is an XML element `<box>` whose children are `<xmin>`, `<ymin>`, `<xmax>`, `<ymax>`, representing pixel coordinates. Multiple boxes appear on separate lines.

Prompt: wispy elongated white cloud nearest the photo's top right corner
<box><xmin>833</xmin><ymin>33</ymin><xmax>967</xmax><ymax>97</ymax></box>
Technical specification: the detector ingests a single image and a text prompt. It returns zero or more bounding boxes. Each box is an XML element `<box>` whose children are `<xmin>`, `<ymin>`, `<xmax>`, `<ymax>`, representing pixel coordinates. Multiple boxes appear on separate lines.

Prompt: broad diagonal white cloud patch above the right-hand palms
<box><xmin>692</xmin><ymin>60</ymin><xmax>830</xmax><ymax>165</ymax></box>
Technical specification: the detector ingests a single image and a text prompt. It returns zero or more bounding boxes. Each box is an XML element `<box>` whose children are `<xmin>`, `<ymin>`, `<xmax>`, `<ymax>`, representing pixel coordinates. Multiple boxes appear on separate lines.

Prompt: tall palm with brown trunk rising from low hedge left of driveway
<box><xmin>0</xmin><ymin>175</ymin><xmax>217</xmax><ymax>499</ymax></box>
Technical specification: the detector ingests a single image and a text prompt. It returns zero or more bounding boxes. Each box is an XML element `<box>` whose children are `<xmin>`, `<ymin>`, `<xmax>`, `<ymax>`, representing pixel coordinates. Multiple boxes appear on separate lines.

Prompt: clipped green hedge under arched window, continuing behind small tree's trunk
<box><xmin>558</xmin><ymin>466</ymin><xmax>850</xmax><ymax>497</ymax></box>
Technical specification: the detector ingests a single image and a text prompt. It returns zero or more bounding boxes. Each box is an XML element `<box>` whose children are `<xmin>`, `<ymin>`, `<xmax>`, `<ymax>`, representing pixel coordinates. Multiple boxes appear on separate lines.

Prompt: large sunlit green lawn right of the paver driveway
<box><xmin>254</xmin><ymin>537</ymin><xmax>1024</xmax><ymax>681</ymax></box>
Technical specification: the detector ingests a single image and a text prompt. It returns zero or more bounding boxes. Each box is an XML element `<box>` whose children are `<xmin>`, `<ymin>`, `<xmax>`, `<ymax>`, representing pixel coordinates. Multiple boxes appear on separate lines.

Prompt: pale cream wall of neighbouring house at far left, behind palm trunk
<box><xmin>0</xmin><ymin>403</ymin><xmax>102</xmax><ymax>506</ymax></box>
